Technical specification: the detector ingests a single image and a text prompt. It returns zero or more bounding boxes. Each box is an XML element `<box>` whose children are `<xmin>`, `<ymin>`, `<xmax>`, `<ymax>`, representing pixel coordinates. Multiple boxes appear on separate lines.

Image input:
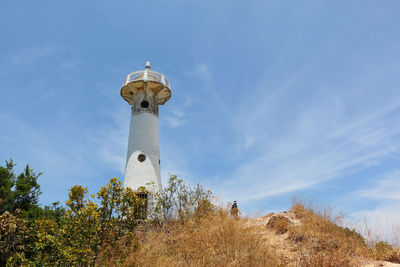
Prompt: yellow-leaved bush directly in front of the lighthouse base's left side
<box><xmin>63</xmin><ymin>178</ymin><xmax>146</xmax><ymax>265</ymax></box>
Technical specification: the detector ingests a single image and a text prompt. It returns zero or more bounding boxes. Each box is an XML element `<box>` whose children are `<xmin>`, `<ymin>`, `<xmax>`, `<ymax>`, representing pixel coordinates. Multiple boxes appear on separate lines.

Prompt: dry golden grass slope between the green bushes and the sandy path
<box><xmin>126</xmin><ymin>210</ymin><xmax>279</xmax><ymax>266</ymax></box>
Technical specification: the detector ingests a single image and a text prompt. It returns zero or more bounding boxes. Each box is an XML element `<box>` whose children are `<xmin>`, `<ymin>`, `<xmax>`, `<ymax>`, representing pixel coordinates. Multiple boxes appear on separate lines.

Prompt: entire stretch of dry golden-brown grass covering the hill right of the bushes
<box><xmin>98</xmin><ymin>200</ymin><xmax>400</xmax><ymax>267</ymax></box>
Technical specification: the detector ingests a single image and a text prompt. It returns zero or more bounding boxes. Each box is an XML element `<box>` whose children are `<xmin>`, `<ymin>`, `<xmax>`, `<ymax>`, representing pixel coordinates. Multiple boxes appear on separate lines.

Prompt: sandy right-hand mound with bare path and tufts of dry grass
<box><xmin>246</xmin><ymin>210</ymin><xmax>400</xmax><ymax>267</ymax></box>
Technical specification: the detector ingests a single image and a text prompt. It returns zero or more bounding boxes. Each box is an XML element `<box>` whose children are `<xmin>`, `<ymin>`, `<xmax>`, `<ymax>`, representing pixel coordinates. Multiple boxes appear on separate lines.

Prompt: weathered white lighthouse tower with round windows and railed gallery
<box><xmin>121</xmin><ymin>61</ymin><xmax>171</xmax><ymax>197</ymax></box>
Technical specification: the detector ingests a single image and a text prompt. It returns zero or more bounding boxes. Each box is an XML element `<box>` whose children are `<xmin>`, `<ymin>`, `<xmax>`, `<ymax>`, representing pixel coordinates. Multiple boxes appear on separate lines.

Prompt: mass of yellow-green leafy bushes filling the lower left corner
<box><xmin>0</xmin><ymin>174</ymin><xmax>150</xmax><ymax>266</ymax></box>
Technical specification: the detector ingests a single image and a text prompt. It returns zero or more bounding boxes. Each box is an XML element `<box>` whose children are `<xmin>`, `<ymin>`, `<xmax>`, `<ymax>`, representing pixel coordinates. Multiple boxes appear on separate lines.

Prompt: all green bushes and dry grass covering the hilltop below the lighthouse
<box><xmin>0</xmin><ymin>160</ymin><xmax>400</xmax><ymax>266</ymax></box>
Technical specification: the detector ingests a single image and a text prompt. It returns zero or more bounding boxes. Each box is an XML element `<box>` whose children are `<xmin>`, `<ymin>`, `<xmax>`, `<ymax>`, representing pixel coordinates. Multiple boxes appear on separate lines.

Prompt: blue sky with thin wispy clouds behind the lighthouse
<box><xmin>0</xmin><ymin>0</ymin><xmax>400</xmax><ymax>241</ymax></box>
